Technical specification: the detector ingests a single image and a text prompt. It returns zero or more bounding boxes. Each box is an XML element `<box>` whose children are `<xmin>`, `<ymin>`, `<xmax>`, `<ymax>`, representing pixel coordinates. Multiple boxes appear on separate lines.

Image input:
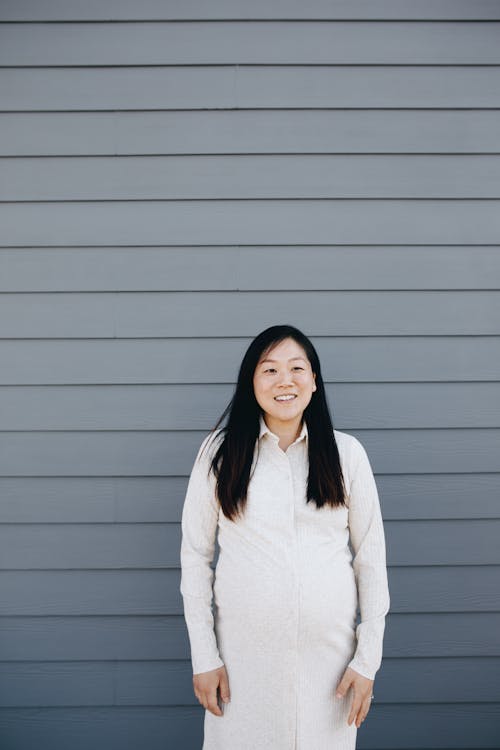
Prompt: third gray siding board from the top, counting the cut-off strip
<box><xmin>0</xmin><ymin>65</ymin><xmax>500</xmax><ymax>112</ymax></box>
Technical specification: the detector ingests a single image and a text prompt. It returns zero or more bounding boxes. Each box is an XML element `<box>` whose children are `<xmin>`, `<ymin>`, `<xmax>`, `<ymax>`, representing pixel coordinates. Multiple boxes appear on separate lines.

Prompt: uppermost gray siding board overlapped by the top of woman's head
<box><xmin>0</xmin><ymin>290</ymin><xmax>500</xmax><ymax>338</ymax></box>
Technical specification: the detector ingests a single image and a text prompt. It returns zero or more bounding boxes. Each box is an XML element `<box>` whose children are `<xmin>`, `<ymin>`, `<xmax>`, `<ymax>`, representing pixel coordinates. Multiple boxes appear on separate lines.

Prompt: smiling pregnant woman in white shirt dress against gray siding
<box><xmin>180</xmin><ymin>325</ymin><xmax>389</xmax><ymax>750</ymax></box>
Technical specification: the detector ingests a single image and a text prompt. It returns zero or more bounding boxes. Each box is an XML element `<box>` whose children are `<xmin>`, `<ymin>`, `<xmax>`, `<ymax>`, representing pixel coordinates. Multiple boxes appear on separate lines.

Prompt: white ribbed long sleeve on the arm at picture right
<box><xmin>348</xmin><ymin>438</ymin><xmax>390</xmax><ymax>680</ymax></box>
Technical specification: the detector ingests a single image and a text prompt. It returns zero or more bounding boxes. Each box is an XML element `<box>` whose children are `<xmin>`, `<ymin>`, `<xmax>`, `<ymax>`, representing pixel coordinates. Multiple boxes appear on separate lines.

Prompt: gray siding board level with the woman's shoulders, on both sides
<box><xmin>0</xmin><ymin>428</ymin><xmax>500</xmax><ymax>477</ymax></box>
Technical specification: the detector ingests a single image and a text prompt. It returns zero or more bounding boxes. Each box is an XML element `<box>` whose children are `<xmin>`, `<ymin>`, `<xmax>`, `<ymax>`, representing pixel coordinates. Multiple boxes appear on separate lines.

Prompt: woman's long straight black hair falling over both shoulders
<box><xmin>201</xmin><ymin>325</ymin><xmax>346</xmax><ymax>520</ymax></box>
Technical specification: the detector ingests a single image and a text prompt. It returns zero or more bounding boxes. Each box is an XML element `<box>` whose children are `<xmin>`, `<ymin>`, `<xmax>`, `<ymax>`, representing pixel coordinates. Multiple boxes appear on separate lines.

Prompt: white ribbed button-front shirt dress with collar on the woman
<box><xmin>180</xmin><ymin>416</ymin><xmax>390</xmax><ymax>750</ymax></box>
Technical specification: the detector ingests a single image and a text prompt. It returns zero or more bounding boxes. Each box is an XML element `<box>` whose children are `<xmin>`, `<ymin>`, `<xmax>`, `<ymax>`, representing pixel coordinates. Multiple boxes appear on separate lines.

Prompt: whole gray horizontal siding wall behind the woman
<box><xmin>0</xmin><ymin>0</ymin><xmax>500</xmax><ymax>750</ymax></box>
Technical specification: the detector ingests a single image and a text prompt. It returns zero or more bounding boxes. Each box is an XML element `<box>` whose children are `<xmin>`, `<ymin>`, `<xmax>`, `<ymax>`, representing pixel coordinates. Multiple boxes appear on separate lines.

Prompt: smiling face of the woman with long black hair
<box><xmin>253</xmin><ymin>338</ymin><xmax>316</xmax><ymax>429</ymax></box>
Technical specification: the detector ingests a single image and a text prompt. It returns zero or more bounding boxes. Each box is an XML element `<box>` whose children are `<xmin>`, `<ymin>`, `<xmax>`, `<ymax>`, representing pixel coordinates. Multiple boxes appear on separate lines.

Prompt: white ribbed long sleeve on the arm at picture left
<box><xmin>180</xmin><ymin>435</ymin><xmax>223</xmax><ymax>674</ymax></box>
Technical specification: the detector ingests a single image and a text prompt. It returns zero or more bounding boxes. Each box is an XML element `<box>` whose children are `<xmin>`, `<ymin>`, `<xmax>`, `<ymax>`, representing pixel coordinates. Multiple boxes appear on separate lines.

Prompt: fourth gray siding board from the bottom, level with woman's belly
<box><xmin>0</xmin><ymin>565</ymin><xmax>500</xmax><ymax>617</ymax></box>
